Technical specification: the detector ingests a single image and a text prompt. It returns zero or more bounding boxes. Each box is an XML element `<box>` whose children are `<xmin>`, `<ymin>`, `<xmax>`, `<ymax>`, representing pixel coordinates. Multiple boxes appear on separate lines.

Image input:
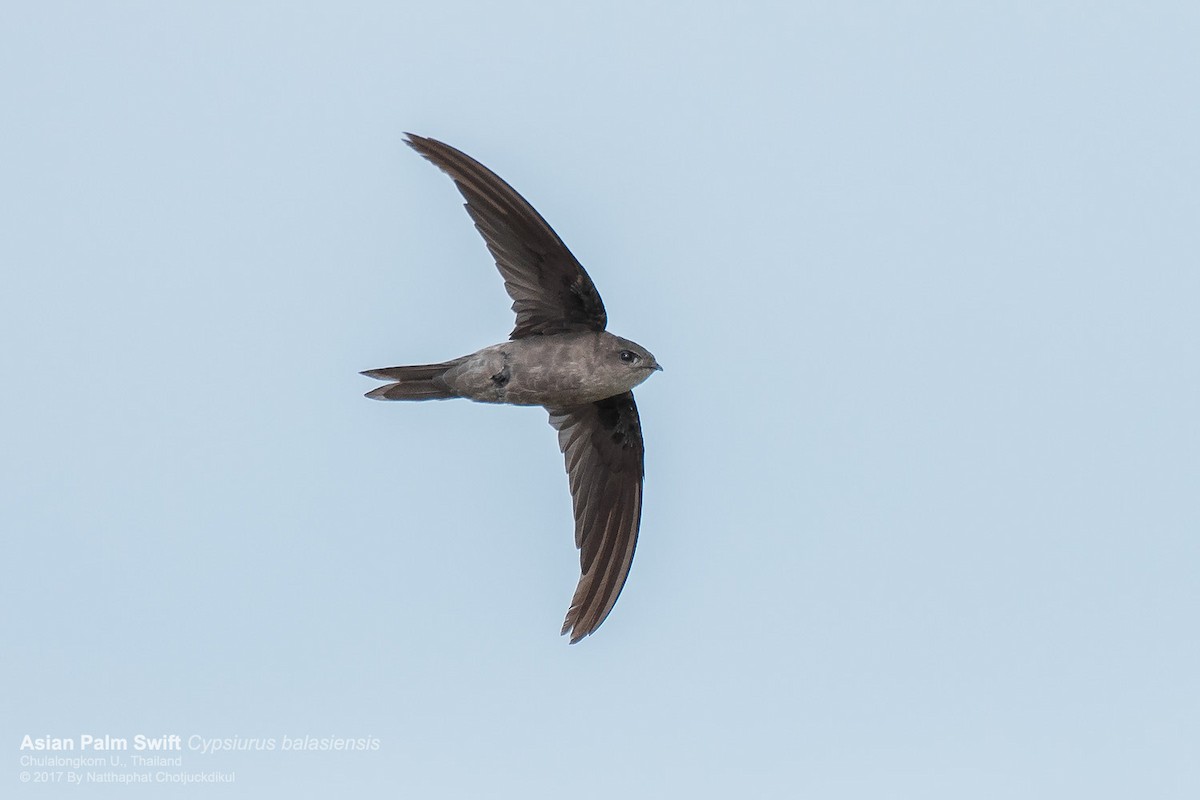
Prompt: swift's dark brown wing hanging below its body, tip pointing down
<box><xmin>550</xmin><ymin>392</ymin><xmax>644</xmax><ymax>644</ymax></box>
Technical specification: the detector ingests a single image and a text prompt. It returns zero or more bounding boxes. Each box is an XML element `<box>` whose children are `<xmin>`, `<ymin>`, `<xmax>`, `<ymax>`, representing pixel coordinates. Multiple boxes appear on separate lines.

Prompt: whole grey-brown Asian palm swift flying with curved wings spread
<box><xmin>362</xmin><ymin>133</ymin><xmax>662</xmax><ymax>644</ymax></box>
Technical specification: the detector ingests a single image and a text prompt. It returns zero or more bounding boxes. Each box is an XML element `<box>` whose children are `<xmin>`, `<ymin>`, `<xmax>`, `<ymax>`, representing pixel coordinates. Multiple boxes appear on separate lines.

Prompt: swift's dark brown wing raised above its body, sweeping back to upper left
<box><xmin>407</xmin><ymin>133</ymin><xmax>607</xmax><ymax>339</ymax></box>
